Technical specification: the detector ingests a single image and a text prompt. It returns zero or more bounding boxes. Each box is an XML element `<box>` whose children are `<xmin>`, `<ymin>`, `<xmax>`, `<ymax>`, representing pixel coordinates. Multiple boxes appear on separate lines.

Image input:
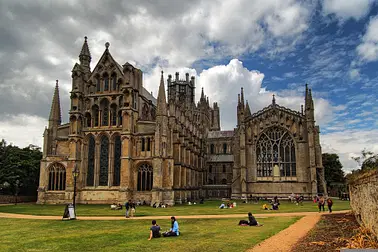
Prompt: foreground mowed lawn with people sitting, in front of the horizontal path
<box><xmin>0</xmin><ymin>217</ymin><xmax>300</xmax><ymax>252</ymax></box>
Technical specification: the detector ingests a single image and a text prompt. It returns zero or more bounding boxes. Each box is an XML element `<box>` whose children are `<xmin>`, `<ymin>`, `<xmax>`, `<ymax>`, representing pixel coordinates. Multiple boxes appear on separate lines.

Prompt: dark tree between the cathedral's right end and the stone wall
<box><xmin>322</xmin><ymin>153</ymin><xmax>345</xmax><ymax>187</ymax></box>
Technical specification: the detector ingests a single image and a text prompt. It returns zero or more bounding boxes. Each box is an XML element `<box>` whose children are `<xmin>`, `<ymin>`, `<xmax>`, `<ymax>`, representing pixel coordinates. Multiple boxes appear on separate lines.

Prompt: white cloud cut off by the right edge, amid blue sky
<box><xmin>357</xmin><ymin>16</ymin><xmax>378</xmax><ymax>62</ymax></box>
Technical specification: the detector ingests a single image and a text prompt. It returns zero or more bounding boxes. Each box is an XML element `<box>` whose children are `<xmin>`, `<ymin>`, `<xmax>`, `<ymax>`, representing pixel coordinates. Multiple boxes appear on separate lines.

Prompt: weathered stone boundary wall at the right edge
<box><xmin>349</xmin><ymin>170</ymin><xmax>378</xmax><ymax>237</ymax></box>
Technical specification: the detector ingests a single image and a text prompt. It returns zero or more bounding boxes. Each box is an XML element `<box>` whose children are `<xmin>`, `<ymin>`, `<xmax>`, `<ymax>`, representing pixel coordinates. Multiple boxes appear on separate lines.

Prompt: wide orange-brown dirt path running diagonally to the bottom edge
<box><xmin>247</xmin><ymin>214</ymin><xmax>321</xmax><ymax>252</ymax></box>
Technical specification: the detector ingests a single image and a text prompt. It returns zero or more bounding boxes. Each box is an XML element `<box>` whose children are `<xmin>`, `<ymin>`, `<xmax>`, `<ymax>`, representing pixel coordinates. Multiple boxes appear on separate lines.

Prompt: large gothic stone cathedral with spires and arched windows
<box><xmin>38</xmin><ymin>37</ymin><xmax>325</xmax><ymax>205</ymax></box>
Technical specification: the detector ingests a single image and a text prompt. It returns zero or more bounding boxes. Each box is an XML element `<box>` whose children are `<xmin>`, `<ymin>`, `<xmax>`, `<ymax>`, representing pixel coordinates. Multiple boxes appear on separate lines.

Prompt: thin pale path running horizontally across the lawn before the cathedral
<box><xmin>0</xmin><ymin>210</ymin><xmax>349</xmax><ymax>220</ymax></box>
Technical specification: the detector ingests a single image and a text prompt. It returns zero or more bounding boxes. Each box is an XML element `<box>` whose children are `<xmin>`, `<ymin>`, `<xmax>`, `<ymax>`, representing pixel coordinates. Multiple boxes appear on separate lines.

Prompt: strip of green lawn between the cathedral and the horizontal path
<box><xmin>0</xmin><ymin>200</ymin><xmax>350</xmax><ymax>216</ymax></box>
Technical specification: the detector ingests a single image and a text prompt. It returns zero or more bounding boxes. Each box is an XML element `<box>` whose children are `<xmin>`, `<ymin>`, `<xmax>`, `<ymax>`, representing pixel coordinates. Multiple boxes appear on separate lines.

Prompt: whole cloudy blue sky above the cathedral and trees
<box><xmin>0</xmin><ymin>0</ymin><xmax>378</xmax><ymax>171</ymax></box>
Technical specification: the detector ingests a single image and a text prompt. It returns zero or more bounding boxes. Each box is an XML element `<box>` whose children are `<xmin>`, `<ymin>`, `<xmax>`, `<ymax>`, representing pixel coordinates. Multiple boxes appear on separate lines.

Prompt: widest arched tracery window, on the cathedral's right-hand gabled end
<box><xmin>256</xmin><ymin>127</ymin><xmax>297</xmax><ymax>177</ymax></box>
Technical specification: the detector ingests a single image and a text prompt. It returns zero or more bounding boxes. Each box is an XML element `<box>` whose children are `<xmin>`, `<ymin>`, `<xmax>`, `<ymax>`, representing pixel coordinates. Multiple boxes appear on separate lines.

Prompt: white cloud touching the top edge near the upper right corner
<box><xmin>323</xmin><ymin>0</ymin><xmax>374</xmax><ymax>20</ymax></box>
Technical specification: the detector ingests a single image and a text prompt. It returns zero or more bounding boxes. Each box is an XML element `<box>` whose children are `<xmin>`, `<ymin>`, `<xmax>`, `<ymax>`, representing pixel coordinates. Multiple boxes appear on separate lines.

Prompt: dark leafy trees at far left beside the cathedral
<box><xmin>0</xmin><ymin>139</ymin><xmax>42</xmax><ymax>195</ymax></box>
